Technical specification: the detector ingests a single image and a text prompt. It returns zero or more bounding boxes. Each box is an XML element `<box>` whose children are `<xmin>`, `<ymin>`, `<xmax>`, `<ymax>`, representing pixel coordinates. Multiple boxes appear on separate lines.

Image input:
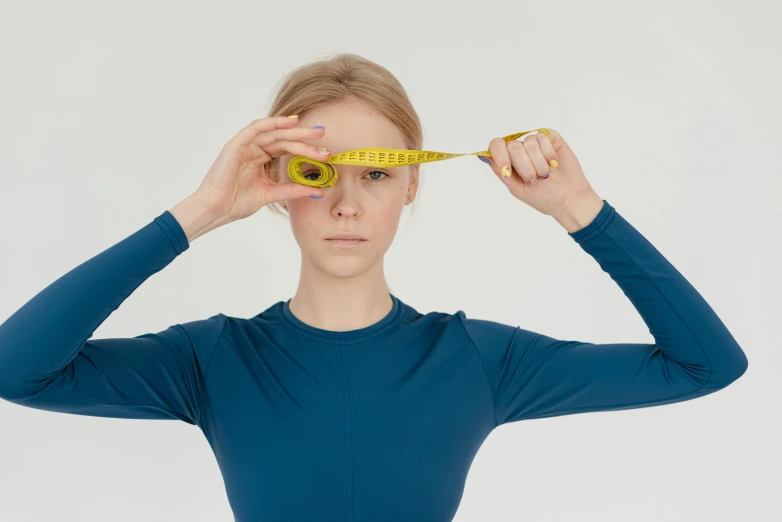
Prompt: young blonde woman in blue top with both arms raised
<box><xmin>0</xmin><ymin>54</ymin><xmax>747</xmax><ymax>522</ymax></box>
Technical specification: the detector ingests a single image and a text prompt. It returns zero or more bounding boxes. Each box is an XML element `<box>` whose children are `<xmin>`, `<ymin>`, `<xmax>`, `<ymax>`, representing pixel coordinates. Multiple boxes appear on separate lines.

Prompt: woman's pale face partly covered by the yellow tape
<box><xmin>278</xmin><ymin>101</ymin><xmax>419</xmax><ymax>277</ymax></box>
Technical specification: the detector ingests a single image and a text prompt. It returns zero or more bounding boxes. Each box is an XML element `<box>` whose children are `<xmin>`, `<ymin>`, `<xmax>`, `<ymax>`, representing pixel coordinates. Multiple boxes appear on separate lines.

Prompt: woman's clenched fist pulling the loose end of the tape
<box><xmin>484</xmin><ymin>129</ymin><xmax>594</xmax><ymax>216</ymax></box>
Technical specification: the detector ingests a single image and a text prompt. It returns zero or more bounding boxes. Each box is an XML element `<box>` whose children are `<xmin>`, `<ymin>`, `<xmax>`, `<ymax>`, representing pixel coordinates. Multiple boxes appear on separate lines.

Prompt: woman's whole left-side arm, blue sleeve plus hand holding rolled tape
<box><xmin>0</xmin><ymin>116</ymin><xmax>338</xmax><ymax>424</ymax></box>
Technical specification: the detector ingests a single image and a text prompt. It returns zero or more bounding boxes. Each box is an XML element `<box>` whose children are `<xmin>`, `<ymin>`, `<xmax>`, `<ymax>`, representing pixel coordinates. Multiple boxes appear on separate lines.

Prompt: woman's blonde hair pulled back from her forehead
<box><xmin>266</xmin><ymin>53</ymin><xmax>423</xmax><ymax>217</ymax></box>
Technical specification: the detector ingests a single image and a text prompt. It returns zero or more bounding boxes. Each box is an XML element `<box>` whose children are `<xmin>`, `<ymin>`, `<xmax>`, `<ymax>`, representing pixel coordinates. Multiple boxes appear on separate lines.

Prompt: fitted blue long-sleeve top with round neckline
<box><xmin>0</xmin><ymin>200</ymin><xmax>747</xmax><ymax>522</ymax></box>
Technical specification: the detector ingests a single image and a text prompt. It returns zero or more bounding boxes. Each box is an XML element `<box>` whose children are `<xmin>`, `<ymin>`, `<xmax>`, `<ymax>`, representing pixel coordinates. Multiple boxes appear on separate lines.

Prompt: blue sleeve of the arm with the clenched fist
<box><xmin>457</xmin><ymin>201</ymin><xmax>747</xmax><ymax>425</ymax></box>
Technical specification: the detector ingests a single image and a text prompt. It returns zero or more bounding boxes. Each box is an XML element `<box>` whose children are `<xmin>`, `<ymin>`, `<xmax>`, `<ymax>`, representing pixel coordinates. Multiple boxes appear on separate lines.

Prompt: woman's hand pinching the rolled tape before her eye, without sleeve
<box><xmin>192</xmin><ymin>116</ymin><xmax>329</xmax><ymax>222</ymax></box>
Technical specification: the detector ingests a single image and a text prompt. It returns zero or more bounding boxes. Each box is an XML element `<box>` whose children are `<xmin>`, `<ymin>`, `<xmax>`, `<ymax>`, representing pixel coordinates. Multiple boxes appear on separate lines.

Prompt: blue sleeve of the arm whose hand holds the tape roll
<box><xmin>0</xmin><ymin>207</ymin><xmax>226</xmax><ymax>424</ymax></box>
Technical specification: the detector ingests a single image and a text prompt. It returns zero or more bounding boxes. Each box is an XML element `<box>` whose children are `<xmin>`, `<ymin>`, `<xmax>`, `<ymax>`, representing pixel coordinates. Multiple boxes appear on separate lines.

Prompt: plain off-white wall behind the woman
<box><xmin>0</xmin><ymin>0</ymin><xmax>782</xmax><ymax>522</ymax></box>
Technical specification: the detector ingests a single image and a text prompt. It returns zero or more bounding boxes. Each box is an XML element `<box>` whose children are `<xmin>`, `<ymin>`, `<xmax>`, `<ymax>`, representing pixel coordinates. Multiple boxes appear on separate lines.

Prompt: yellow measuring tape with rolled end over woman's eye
<box><xmin>288</xmin><ymin>128</ymin><xmax>551</xmax><ymax>187</ymax></box>
